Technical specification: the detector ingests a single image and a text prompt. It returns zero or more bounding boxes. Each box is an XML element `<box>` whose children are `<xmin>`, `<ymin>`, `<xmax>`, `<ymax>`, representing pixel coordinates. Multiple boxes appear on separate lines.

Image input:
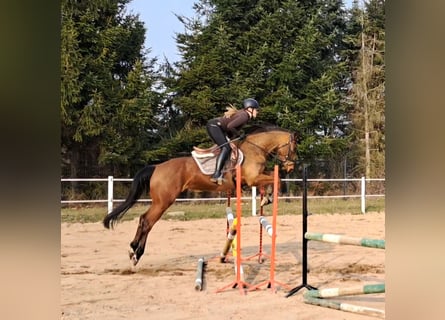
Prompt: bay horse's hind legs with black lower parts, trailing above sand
<box><xmin>129</xmin><ymin>199</ymin><xmax>174</xmax><ymax>265</ymax></box>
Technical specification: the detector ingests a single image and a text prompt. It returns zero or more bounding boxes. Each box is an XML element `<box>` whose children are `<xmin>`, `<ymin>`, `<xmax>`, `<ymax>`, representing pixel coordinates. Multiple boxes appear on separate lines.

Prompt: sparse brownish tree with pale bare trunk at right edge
<box><xmin>349</xmin><ymin>0</ymin><xmax>385</xmax><ymax>177</ymax></box>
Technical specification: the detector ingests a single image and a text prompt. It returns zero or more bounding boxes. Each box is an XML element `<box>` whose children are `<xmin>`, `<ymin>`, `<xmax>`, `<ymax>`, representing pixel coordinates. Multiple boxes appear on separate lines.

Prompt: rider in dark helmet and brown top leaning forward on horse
<box><xmin>207</xmin><ymin>98</ymin><xmax>260</xmax><ymax>184</ymax></box>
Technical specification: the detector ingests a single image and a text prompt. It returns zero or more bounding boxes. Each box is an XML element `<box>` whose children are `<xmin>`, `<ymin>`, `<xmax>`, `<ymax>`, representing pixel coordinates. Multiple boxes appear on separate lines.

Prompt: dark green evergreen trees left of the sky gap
<box><xmin>60</xmin><ymin>0</ymin><xmax>161</xmax><ymax>177</ymax></box>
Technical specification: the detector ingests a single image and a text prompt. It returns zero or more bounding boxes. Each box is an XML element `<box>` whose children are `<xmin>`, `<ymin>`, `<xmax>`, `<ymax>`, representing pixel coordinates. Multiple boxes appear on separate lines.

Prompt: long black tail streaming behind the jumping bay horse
<box><xmin>103</xmin><ymin>165</ymin><xmax>156</xmax><ymax>229</ymax></box>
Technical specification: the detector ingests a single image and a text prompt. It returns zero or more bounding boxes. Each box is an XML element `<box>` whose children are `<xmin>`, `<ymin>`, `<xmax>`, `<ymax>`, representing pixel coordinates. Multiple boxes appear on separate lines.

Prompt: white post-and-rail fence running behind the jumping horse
<box><xmin>60</xmin><ymin>176</ymin><xmax>385</xmax><ymax>214</ymax></box>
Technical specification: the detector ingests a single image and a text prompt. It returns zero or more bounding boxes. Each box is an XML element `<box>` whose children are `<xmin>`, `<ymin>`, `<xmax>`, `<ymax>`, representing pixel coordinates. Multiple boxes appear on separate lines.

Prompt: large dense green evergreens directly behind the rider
<box><xmin>161</xmin><ymin>0</ymin><xmax>348</xmax><ymax>172</ymax></box>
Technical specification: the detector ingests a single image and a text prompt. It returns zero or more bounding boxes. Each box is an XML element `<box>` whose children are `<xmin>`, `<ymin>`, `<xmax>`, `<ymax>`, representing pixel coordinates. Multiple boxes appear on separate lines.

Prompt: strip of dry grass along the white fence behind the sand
<box><xmin>61</xmin><ymin>198</ymin><xmax>385</xmax><ymax>223</ymax></box>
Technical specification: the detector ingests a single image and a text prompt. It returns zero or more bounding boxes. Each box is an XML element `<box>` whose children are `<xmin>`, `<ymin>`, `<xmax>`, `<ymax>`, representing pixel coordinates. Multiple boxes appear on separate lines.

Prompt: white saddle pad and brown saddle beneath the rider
<box><xmin>191</xmin><ymin>142</ymin><xmax>244</xmax><ymax>175</ymax></box>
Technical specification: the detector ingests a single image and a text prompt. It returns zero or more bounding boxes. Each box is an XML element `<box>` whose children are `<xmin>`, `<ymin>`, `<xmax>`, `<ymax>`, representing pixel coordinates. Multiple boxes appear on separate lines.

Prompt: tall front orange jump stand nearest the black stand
<box><xmin>250</xmin><ymin>165</ymin><xmax>290</xmax><ymax>293</ymax></box>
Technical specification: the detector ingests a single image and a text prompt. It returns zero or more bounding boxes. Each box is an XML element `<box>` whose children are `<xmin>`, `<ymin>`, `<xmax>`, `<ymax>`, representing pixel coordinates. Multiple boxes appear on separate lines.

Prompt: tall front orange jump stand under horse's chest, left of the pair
<box><xmin>216</xmin><ymin>165</ymin><xmax>252</xmax><ymax>294</ymax></box>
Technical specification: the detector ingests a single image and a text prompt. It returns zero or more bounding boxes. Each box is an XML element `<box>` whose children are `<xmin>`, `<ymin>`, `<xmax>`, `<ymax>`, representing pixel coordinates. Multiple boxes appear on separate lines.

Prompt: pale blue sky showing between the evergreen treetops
<box><xmin>127</xmin><ymin>0</ymin><xmax>352</xmax><ymax>62</ymax></box>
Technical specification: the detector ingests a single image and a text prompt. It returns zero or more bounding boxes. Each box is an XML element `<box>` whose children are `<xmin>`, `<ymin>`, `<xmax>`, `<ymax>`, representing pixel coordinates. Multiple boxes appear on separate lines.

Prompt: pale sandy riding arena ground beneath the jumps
<box><xmin>61</xmin><ymin>212</ymin><xmax>385</xmax><ymax>320</ymax></box>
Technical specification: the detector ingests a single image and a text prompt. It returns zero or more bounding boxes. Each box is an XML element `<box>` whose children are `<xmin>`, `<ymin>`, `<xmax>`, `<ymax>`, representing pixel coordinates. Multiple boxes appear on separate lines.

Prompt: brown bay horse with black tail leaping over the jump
<box><xmin>103</xmin><ymin>126</ymin><xmax>297</xmax><ymax>265</ymax></box>
